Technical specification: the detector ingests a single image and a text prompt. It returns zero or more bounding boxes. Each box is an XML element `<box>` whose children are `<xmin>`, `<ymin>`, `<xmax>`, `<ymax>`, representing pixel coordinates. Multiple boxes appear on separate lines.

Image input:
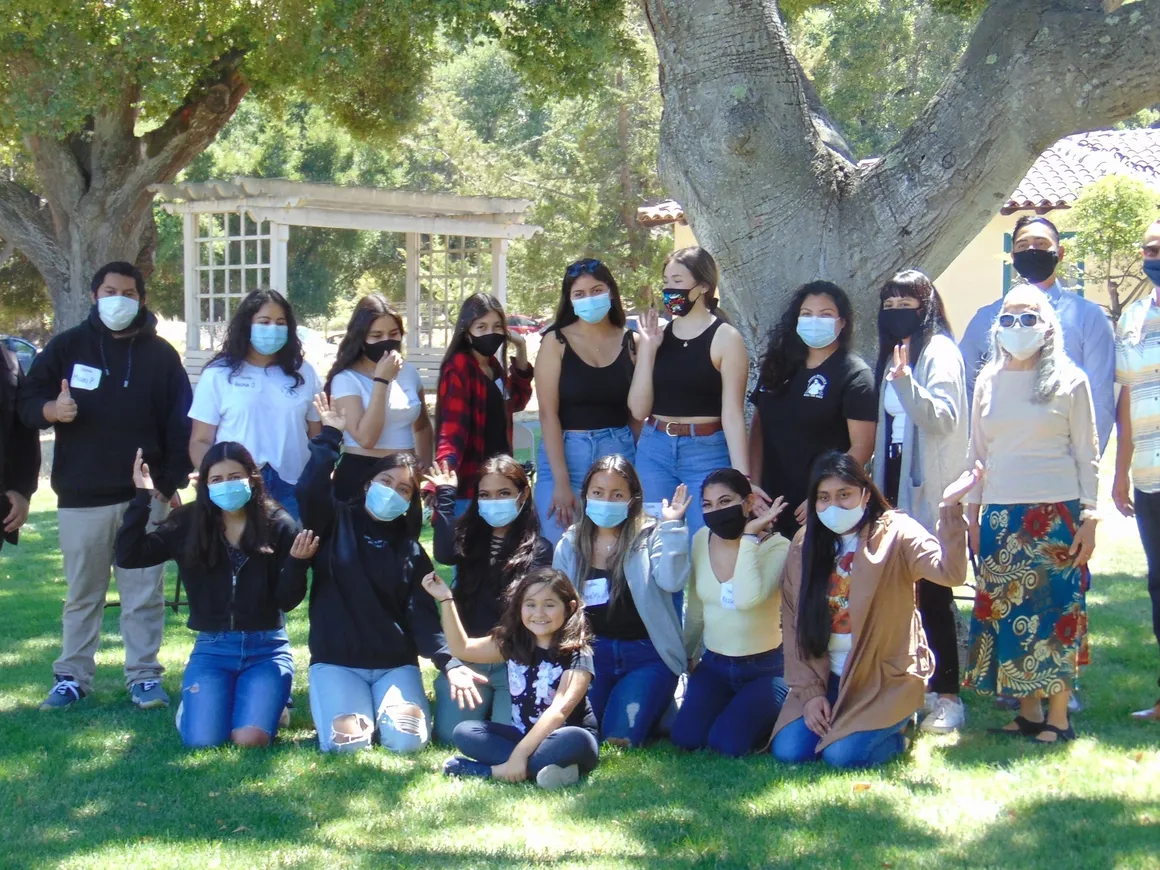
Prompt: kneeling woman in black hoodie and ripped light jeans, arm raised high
<box><xmin>297</xmin><ymin>393</ymin><xmax>443</xmax><ymax>752</ymax></box>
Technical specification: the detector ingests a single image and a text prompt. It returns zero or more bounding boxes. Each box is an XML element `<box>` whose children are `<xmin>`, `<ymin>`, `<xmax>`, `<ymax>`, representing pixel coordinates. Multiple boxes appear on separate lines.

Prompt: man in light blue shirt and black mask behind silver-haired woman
<box><xmin>958</xmin><ymin>215</ymin><xmax>1116</xmax><ymax>454</ymax></box>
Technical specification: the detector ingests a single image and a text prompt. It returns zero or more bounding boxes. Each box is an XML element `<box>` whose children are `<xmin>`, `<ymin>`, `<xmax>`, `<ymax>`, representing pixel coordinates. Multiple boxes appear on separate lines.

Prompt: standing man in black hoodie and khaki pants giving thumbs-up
<box><xmin>20</xmin><ymin>262</ymin><xmax>191</xmax><ymax>710</ymax></box>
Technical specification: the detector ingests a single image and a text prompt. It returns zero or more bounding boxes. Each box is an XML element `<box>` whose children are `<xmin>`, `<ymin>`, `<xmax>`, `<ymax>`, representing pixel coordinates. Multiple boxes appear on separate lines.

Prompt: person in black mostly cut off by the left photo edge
<box><xmin>0</xmin><ymin>346</ymin><xmax>41</xmax><ymax>548</ymax></box>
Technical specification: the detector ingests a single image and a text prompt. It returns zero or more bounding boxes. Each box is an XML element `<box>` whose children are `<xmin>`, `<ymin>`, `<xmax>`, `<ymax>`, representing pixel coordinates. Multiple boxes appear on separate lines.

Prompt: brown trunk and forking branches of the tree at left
<box><xmin>0</xmin><ymin>56</ymin><xmax>249</xmax><ymax>332</ymax></box>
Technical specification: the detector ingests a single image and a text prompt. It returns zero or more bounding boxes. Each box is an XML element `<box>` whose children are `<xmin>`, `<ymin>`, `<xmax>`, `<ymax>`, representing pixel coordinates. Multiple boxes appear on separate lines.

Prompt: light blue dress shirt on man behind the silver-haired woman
<box><xmin>958</xmin><ymin>280</ymin><xmax>1116</xmax><ymax>454</ymax></box>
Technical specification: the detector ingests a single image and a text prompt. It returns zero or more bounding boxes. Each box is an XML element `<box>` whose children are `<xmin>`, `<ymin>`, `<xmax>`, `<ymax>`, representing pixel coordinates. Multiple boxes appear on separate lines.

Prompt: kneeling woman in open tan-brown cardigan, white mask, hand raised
<box><xmin>773</xmin><ymin>451</ymin><xmax>983</xmax><ymax>768</ymax></box>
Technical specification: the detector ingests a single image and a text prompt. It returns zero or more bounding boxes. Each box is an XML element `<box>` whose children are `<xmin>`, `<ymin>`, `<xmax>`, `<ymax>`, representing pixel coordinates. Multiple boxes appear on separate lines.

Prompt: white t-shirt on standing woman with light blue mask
<box><xmin>189</xmin><ymin>362</ymin><xmax>322</xmax><ymax>484</ymax></box>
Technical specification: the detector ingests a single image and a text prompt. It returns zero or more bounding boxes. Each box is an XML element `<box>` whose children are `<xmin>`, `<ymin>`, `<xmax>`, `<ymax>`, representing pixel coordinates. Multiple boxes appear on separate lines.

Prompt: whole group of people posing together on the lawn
<box><xmin>0</xmin><ymin>216</ymin><xmax>1160</xmax><ymax>788</ymax></box>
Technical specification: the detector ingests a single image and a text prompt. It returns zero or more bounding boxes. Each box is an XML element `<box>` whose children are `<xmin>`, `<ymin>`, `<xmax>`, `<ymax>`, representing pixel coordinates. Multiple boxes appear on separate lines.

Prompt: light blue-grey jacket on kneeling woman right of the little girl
<box><xmin>552</xmin><ymin>520</ymin><xmax>689</xmax><ymax>676</ymax></box>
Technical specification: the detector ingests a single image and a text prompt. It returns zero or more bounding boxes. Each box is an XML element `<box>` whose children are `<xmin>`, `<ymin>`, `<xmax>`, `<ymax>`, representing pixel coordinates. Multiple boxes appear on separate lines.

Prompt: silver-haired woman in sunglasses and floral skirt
<box><xmin>964</xmin><ymin>287</ymin><xmax>1100</xmax><ymax>744</ymax></box>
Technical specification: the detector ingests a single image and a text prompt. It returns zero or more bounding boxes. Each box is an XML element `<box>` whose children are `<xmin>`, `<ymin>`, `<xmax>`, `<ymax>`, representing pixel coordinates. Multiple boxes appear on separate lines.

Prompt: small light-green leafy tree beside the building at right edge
<box><xmin>1060</xmin><ymin>175</ymin><xmax>1160</xmax><ymax>319</ymax></box>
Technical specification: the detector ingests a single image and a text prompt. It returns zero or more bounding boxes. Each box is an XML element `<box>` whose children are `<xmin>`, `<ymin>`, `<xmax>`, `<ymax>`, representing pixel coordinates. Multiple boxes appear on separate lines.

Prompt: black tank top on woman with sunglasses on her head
<box><xmin>556</xmin><ymin>329</ymin><xmax>636</xmax><ymax>430</ymax></box>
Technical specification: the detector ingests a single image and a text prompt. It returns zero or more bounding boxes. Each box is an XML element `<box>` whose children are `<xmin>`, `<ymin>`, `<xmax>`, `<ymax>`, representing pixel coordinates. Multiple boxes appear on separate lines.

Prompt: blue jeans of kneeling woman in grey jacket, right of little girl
<box><xmin>588</xmin><ymin>637</ymin><xmax>677</xmax><ymax>746</ymax></box>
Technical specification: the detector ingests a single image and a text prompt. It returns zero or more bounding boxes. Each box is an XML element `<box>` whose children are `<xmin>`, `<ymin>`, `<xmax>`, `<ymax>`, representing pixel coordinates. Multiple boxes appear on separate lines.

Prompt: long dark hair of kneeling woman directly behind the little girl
<box><xmin>454</xmin><ymin>455</ymin><xmax>539</xmax><ymax>608</ymax></box>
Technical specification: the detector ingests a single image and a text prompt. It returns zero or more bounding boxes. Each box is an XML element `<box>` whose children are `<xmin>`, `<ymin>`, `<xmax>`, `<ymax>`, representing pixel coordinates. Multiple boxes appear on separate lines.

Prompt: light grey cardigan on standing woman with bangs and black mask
<box><xmin>873</xmin><ymin>335</ymin><xmax>971</xmax><ymax>531</ymax></box>
